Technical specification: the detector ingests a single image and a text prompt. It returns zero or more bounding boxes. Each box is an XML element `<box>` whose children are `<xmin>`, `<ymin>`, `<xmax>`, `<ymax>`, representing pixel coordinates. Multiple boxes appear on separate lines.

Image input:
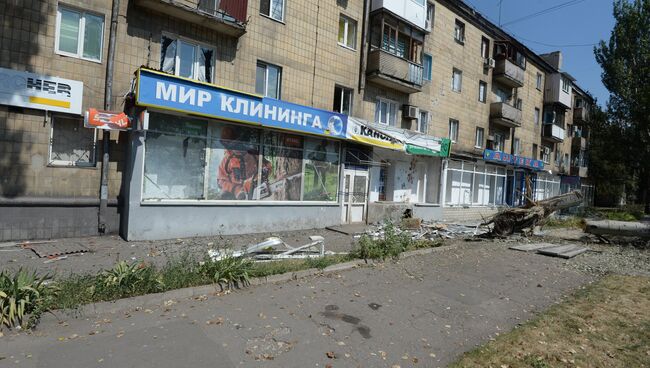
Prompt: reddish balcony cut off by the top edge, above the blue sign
<box><xmin>135</xmin><ymin>0</ymin><xmax>248</xmax><ymax>37</ymax></box>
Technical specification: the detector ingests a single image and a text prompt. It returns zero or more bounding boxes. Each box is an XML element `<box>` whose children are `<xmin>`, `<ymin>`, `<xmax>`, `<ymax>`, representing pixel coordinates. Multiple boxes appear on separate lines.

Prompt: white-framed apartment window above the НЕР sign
<box><xmin>55</xmin><ymin>4</ymin><xmax>104</xmax><ymax>62</ymax></box>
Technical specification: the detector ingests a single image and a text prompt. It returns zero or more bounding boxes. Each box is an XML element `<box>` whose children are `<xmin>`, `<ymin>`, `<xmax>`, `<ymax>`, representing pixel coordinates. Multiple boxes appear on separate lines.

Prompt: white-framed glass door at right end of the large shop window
<box><xmin>341</xmin><ymin>168</ymin><xmax>368</xmax><ymax>224</ymax></box>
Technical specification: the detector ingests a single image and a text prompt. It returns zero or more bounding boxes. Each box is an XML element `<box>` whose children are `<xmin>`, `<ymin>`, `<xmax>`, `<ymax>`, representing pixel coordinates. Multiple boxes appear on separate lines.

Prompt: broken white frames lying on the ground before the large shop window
<box><xmin>208</xmin><ymin>235</ymin><xmax>342</xmax><ymax>261</ymax></box>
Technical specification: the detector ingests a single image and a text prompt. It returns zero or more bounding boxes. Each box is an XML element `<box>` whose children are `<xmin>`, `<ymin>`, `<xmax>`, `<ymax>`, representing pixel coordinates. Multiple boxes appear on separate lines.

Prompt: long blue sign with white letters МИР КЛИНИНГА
<box><xmin>136</xmin><ymin>69</ymin><xmax>347</xmax><ymax>139</ymax></box>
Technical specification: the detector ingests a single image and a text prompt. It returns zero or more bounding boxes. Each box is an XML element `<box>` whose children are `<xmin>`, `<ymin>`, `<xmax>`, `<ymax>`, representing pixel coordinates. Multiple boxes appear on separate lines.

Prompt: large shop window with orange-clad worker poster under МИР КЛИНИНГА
<box><xmin>143</xmin><ymin>113</ymin><xmax>340</xmax><ymax>202</ymax></box>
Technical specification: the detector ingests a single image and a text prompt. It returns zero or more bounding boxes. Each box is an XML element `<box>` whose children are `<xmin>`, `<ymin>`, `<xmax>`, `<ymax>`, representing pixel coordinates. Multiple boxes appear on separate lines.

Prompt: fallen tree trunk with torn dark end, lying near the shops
<box><xmin>483</xmin><ymin>190</ymin><xmax>582</xmax><ymax>236</ymax></box>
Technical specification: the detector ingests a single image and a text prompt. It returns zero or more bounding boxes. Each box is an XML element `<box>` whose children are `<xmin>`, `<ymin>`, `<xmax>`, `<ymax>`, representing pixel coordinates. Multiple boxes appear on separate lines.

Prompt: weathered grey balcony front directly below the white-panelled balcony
<box><xmin>366</xmin><ymin>49</ymin><xmax>424</xmax><ymax>93</ymax></box>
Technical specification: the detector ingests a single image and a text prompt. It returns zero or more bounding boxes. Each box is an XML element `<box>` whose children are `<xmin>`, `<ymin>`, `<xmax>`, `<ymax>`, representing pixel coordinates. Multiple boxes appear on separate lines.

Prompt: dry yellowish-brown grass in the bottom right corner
<box><xmin>450</xmin><ymin>275</ymin><xmax>650</xmax><ymax>368</ymax></box>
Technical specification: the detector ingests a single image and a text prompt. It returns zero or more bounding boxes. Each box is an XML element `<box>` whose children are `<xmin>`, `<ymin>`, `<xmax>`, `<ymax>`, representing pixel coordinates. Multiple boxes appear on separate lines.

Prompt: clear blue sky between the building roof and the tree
<box><xmin>464</xmin><ymin>0</ymin><xmax>614</xmax><ymax>106</ymax></box>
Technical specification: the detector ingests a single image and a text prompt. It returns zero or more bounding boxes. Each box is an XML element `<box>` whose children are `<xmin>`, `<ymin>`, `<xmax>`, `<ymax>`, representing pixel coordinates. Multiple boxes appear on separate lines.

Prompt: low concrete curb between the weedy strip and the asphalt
<box><xmin>41</xmin><ymin>245</ymin><xmax>455</xmax><ymax>323</ymax></box>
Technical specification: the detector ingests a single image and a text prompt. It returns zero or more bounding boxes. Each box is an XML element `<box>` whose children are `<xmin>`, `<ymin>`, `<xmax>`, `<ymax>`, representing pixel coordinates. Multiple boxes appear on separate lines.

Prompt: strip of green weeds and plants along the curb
<box><xmin>0</xmin><ymin>229</ymin><xmax>442</xmax><ymax>328</ymax></box>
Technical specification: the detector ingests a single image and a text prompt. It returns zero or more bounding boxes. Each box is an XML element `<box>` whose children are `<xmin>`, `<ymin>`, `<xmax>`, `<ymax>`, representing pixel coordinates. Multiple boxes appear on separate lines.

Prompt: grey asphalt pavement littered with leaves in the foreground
<box><xmin>0</xmin><ymin>243</ymin><xmax>590</xmax><ymax>368</ymax></box>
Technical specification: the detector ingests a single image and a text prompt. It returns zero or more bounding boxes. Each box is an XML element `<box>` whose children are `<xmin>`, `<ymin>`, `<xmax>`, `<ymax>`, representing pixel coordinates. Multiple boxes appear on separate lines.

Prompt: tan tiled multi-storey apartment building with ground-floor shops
<box><xmin>0</xmin><ymin>0</ymin><xmax>591</xmax><ymax>240</ymax></box>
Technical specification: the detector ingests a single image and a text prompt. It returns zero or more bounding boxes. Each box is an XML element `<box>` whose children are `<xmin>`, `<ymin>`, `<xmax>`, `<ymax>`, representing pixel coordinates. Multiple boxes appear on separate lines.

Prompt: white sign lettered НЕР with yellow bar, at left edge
<box><xmin>0</xmin><ymin>68</ymin><xmax>84</xmax><ymax>115</ymax></box>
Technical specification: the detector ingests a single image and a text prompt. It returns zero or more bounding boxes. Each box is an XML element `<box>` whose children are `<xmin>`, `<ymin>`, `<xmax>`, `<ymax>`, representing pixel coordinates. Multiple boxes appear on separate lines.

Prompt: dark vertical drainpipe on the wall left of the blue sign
<box><xmin>97</xmin><ymin>0</ymin><xmax>120</xmax><ymax>234</ymax></box>
